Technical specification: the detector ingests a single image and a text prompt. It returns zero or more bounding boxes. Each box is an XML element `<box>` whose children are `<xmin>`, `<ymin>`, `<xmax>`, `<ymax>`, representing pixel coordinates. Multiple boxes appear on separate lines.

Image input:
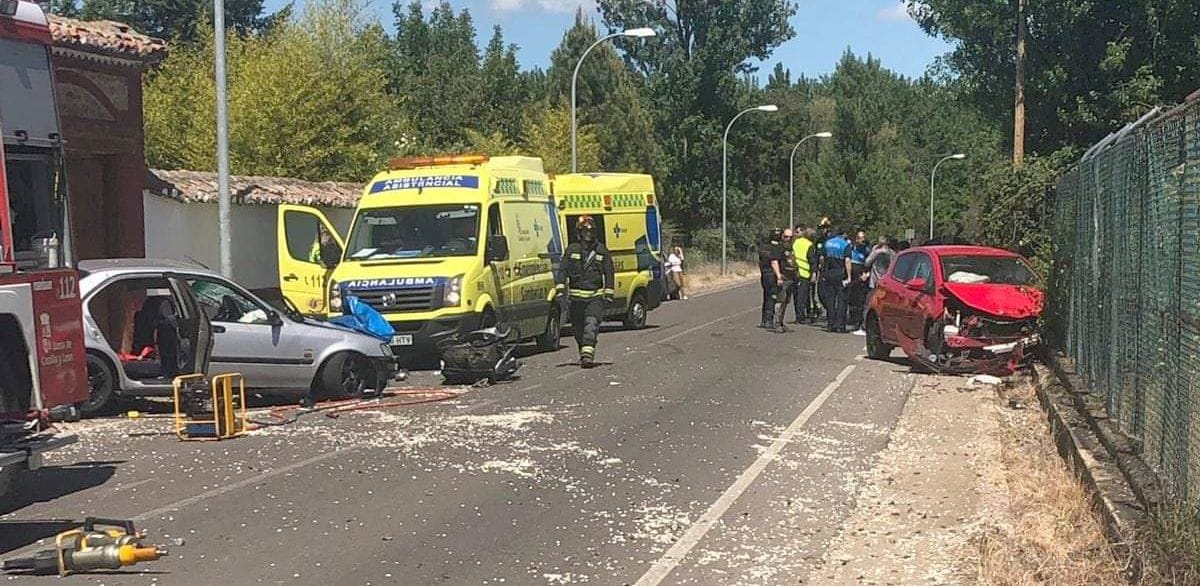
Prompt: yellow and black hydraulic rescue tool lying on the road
<box><xmin>0</xmin><ymin>518</ymin><xmax>167</xmax><ymax>576</ymax></box>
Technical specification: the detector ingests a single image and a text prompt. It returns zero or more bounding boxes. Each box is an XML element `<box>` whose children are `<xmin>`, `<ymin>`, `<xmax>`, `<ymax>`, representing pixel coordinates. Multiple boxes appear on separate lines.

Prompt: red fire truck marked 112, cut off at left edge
<box><xmin>0</xmin><ymin>0</ymin><xmax>89</xmax><ymax>495</ymax></box>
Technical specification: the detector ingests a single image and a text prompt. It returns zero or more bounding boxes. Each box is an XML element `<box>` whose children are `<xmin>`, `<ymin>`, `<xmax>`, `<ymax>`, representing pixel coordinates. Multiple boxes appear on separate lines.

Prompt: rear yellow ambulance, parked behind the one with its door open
<box><xmin>553</xmin><ymin>173</ymin><xmax>665</xmax><ymax>329</ymax></box>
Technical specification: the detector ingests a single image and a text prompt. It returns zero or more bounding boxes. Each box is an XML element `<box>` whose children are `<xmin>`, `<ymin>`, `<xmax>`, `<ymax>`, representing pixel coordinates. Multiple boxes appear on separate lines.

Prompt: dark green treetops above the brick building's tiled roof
<box><xmin>70</xmin><ymin>0</ymin><xmax>269</xmax><ymax>43</ymax></box>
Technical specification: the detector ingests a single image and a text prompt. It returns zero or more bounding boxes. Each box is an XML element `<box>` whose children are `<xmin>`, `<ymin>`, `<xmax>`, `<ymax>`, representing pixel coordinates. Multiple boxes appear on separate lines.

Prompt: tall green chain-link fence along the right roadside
<box><xmin>1048</xmin><ymin>102</ymin><xmax>1200</xmax><ymax>503</ymax></box>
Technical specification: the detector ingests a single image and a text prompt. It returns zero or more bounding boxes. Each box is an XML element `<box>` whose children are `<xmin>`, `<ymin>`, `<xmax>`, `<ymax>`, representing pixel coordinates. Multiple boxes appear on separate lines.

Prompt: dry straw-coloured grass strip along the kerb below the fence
<box><xmin>976</xmin><ymin>385</ymin><xmax>1129</xmax><ymax>586</ymax></box>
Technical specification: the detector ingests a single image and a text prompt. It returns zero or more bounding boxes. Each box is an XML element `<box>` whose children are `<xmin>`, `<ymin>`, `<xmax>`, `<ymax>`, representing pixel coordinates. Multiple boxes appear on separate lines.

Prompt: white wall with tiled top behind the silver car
<box><xmin>143</xmin><ymin>192</ymin><xmax>354</xmax><ymax>291</ymax></box>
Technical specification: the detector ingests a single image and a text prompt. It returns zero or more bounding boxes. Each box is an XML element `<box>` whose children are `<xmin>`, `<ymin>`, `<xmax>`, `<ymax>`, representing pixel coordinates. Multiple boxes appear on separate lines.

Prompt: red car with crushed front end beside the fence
<box><xmin>866</xmin><ymin>246</ymin><xmax>1045</xmax><ymax>373</ymax></box>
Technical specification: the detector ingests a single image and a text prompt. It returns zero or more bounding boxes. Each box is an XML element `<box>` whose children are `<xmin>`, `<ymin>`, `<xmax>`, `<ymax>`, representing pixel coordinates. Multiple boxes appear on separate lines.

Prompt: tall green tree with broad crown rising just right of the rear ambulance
<box><xmin>598</xmin><ymin>0</ymin><xmax>796</xmax><ymax>236</ymax></box>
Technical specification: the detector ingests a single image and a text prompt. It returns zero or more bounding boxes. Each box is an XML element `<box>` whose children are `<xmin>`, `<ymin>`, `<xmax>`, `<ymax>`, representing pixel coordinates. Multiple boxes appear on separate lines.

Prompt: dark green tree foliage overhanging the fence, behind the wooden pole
<box><xmin>911</xmin><ymin>0</ymin><xmax>1200</xmax><ymax>154</ymax></box>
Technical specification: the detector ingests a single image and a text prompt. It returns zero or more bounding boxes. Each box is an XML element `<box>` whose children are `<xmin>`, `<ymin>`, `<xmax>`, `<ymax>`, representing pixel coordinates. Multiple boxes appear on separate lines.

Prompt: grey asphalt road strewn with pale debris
<box><xmin>0</xmin><ymin>280</ymin><xmax>912</xmax><ymax>586</ymax></box>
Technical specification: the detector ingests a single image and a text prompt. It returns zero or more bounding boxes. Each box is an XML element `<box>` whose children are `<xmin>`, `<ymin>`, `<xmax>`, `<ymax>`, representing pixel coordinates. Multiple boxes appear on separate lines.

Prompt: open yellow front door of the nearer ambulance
<box><xmin>276</xmin><ymin>204</ymin><xmax>346</xmax><ymax>315</ymax></box>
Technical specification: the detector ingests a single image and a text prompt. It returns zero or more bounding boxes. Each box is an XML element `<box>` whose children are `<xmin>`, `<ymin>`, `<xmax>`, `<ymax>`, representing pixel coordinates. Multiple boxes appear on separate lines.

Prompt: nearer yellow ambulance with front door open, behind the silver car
<box><xmin>277</xmin><ymin>155</ymin><xmax>564</xmax><ymax>351</ymax></box>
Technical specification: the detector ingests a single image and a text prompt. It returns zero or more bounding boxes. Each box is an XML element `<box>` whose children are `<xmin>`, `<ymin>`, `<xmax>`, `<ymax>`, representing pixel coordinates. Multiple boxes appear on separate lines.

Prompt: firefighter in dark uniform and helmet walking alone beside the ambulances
<box><xmin>556</xmin><ymin>216</ymin><xmax>614</xmax><ymax>369</ymax></box>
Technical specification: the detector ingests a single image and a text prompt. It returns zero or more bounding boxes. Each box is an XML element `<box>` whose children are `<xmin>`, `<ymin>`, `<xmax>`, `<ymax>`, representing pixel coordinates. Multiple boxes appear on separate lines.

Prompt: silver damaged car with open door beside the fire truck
<box><xmin>78</xmin><ymin>258</ymin><xmax>396</xmax><ymax>415</ymax></box>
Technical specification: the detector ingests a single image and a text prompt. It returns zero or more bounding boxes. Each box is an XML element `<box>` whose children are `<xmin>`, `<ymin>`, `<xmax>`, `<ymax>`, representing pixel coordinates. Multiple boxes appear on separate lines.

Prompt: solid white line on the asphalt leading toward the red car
<box><xmin>634</xmin><ymin>361</ymin><xmax>858</xmax><ymax>586</ymax></box>
